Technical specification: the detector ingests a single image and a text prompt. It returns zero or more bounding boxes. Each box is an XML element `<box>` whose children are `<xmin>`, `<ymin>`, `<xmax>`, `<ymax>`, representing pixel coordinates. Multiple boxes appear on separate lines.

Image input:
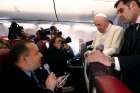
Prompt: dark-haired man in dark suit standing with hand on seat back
<box><xmin>86</xmin><ymin>0</ymin><xmax>140</xmax><ymax>93</ymax></box>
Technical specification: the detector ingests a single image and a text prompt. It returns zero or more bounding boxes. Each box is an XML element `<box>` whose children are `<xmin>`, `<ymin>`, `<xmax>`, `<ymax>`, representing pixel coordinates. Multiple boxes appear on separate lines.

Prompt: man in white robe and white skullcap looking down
<box><xmin>92</xmin><ymin>13</ymin><xmax>124</xmax><ymax>56</ymax></box>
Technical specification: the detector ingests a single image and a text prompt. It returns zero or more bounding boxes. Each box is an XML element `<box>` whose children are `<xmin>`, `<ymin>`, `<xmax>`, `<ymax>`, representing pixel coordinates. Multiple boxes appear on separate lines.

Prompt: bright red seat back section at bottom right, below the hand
<box><xmin>95</xmin><ymin>75</ymin><xmax>132</xmax><ymax>93</ymax></box>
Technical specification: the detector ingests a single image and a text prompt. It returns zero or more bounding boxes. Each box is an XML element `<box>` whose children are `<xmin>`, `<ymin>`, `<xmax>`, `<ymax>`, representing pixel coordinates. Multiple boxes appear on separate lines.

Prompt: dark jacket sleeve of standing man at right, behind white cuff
<box><xmin>118</xmin><ymin>55</ymin><xmax>140</xmax><ymax>93</ymax></box>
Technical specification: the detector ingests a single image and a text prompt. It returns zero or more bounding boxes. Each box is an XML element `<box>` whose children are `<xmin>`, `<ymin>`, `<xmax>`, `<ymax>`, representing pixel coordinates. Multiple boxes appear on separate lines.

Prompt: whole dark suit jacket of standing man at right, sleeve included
<box><xmin>118</xmin><ymin>24</ymin><xmax>140</xmax><ymax>93</ymax></box>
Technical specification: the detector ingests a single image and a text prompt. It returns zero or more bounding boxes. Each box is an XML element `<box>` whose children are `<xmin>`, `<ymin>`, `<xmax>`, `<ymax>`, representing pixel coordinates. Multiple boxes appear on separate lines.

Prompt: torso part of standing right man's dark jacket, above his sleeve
<box><xmin>119</xmin><ymin>23</ymin><xmax>140</xmax><ymax>56</ymax></box>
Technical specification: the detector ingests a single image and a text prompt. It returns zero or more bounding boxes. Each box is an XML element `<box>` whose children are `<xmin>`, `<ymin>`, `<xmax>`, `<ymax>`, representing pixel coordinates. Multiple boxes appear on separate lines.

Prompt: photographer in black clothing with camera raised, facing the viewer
<box><xmin>45</xmin><ymin>37</ymin><xmax>68</xmax><ymax>76</ymax></box>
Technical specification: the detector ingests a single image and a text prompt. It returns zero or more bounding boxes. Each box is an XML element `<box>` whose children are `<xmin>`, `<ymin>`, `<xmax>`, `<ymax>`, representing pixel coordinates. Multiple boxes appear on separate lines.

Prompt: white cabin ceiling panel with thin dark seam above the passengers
<box><xmin>0</xmin><ymin>0</ymin><xmax>116</xmax><ymax>23</ymax></box>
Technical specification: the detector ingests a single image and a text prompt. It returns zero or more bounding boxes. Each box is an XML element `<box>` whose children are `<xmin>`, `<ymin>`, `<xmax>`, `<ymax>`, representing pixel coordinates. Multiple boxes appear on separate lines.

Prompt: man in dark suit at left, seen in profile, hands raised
<box><xmin>2</xmin><ymin>41</ymin><xmax>57</xmax><ymax>93</ymax></box>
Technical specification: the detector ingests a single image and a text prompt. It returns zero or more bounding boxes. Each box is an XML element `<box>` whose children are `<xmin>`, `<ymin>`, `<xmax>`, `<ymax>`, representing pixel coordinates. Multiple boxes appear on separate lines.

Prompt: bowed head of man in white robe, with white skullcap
<box><xmin>94</xmin><ymin>14</ymin><xmax>109</xmax><ymax>33</ymax></box>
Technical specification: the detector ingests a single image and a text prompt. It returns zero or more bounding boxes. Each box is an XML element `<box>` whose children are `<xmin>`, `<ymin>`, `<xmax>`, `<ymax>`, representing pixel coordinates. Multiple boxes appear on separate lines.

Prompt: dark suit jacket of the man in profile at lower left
<box><xmin>1</xmin><ymin>63</ymin><xmax>52</xmax><ymax>93</ymax></box>
